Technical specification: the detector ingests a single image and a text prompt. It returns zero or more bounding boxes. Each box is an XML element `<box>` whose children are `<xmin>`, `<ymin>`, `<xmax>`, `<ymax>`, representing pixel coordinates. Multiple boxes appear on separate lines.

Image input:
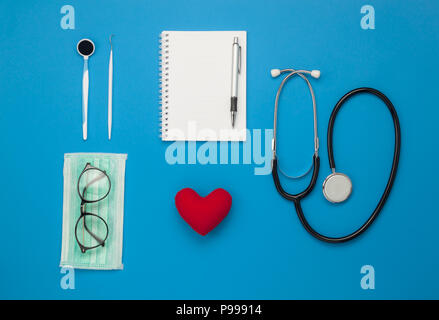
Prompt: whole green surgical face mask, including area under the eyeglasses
<box><xmin>60</xmin><ymin>153</ymin><xmax>127</xmax><ymax>270</ymax></box>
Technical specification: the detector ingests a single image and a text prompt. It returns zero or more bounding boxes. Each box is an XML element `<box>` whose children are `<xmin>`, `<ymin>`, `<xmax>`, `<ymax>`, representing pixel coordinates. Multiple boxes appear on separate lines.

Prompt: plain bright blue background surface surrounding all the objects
<box><xmin>0</xmin><ymin>0</ymin><xmax>439</xmax><ymax>299</ymax></box>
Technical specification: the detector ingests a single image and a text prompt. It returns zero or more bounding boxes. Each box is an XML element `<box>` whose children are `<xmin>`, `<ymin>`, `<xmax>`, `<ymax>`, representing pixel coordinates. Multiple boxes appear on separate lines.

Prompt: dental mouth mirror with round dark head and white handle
<box><xmin>76</xmin><ymin>39</ymin><xmax>95</xmax><ymax>140</ymax></box>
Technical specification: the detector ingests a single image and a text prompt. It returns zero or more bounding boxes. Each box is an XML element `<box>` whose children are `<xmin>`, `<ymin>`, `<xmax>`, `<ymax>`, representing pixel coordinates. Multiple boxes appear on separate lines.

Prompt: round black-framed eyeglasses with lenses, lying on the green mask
<box><xmin>75</xmin><ymin>163</ymin><xmax>111</xmax><ymax>253</ymax></box>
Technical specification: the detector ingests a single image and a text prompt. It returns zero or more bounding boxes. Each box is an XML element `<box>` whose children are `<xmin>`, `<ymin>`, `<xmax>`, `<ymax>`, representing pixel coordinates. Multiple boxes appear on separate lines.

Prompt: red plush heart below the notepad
<box><xmin>175</xmin><ymin>188</ymin><xmax>232</xmax><ymax>236</ymax></box>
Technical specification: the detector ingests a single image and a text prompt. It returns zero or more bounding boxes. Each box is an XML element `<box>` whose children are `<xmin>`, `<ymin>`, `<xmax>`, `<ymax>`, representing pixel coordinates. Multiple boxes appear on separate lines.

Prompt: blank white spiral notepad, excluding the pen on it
<box><xmin>160</xmin><ymin>31</ymin><xmax>247</xmax><ymax>141</ymax></box>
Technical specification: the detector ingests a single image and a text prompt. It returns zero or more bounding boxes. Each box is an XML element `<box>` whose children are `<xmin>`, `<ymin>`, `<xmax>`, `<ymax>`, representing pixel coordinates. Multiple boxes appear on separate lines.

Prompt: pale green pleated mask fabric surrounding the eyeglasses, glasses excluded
<box><xmin>60</xmin><ymin>153</ymin><xmax>127</xmax><ymax>270</ymax></box>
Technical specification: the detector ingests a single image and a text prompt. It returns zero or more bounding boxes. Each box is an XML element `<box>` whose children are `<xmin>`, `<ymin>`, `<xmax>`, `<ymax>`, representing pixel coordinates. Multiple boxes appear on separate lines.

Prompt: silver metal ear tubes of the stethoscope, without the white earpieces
<box><xmin>272</xmin><ymin>69</ymin><xmax>319</xmax><ymax>179</ymax></box>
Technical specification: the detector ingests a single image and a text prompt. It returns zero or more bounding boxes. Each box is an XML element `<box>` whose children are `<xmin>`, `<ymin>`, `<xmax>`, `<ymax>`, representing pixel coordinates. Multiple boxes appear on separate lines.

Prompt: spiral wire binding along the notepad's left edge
<box><xmin>159</xmin><ymin>32</ymin><xmax>169</xmax><ymax>140</ymax></box>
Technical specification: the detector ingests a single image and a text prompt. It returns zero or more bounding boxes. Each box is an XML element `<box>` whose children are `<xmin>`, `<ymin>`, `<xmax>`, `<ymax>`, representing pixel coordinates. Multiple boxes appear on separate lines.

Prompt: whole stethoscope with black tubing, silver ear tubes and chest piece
<box><xmin>271</xmin><ymin>69</ymin><xmax>401</xmax><ymax>243</ymax></box>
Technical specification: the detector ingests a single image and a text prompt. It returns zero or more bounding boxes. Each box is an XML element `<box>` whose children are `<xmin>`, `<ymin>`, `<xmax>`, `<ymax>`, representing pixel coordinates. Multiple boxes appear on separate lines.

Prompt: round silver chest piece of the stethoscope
<box><xmin>323</xmin><ymin>172</ymin><xmax>352</xmax><ymax>203</ymax></box>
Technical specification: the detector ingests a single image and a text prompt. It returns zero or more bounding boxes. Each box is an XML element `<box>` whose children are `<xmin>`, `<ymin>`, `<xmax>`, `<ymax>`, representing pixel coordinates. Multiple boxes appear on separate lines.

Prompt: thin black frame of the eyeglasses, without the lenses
<box><xmin>75</xmin><ymin>162</ymin><xmax>111</xmax><ymax>253</ymax></box>
